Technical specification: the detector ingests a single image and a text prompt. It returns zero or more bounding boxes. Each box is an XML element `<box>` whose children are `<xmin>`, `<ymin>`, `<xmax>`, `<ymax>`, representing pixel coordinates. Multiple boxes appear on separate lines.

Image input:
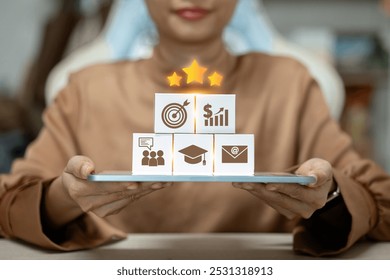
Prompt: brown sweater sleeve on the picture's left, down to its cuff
<box><xmin>0</xmin><ymin>76</ymin><xmax>125</xmax><ymax>250</ymax></box>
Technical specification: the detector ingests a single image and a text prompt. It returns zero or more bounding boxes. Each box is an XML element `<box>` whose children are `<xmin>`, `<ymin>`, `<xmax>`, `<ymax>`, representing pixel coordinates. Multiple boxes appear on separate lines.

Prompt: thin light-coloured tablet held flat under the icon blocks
<box><xmin>88</xmin><ymin>171</ymin><xmax>316</xmax><ymax>185</ymax></box>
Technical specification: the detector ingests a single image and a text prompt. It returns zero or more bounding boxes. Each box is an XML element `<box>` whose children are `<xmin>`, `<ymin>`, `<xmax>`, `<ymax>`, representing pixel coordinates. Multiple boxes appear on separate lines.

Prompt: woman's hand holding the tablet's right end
<box><xmin>233</xmin><ymin>158</ymin><xmax>336</xmax><ymax>219</ymax></box>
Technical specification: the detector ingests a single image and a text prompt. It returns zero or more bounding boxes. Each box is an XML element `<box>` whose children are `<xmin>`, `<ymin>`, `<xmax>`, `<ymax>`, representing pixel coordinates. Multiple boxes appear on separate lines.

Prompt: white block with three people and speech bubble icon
<box><xmin>133</xmin><ymin>133</ymin><xmax>172</xmax><ymax>175</ymax></box>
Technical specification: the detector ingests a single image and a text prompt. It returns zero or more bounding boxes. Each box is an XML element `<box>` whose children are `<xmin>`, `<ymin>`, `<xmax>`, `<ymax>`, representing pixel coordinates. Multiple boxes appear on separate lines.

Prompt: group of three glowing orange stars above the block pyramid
<box><xmin>167</xmin><ymin>59</ymin><xmax>223</xmax><ymax>87</ymax></box>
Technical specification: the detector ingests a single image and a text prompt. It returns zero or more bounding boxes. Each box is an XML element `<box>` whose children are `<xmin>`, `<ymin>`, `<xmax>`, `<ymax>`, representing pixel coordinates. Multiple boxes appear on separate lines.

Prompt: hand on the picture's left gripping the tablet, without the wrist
<box><xmin>62</xmin><ymin>156</ymin><xmax>171</xmax><ymax>217</ymax></box>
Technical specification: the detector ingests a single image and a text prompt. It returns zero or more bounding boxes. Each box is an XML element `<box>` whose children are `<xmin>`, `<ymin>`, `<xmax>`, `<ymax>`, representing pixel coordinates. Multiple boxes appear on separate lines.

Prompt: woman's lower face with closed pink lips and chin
<box><xmin>145</xmin><ymin>0</ymin><xmax>237</xmax><ymax>43</ymax></box>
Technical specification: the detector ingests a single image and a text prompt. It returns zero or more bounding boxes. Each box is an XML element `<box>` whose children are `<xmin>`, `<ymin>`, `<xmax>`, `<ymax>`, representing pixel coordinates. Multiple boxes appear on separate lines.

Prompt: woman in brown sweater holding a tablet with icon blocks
<box><xmin>0</xmin><ymin>0</ymin><xmax>390</xmax><ymax>255</ymax></box>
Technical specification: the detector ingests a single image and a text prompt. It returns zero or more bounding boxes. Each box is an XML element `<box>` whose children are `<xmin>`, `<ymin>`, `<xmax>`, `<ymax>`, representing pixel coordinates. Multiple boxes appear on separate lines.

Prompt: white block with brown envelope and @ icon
<box><xmin>214</xmin><ymin>134</ymin><xmax>255</xmax><ymax>175</ymax></box>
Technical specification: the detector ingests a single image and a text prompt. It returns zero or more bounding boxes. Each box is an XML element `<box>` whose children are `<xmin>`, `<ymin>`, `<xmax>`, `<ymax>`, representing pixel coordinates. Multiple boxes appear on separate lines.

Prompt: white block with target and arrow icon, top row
<box><xmin>154</xmin><ymin>93</ymin><xmax>195</xmax><ymax>133</ymax></box>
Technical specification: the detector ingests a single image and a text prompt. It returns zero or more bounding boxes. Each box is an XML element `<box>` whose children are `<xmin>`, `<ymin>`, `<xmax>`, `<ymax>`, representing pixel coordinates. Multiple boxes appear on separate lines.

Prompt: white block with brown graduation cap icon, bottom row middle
<box><xmin>173</xmin><ymin>134</ymin><xmax>214</xmax><ymax>175</ymax></box>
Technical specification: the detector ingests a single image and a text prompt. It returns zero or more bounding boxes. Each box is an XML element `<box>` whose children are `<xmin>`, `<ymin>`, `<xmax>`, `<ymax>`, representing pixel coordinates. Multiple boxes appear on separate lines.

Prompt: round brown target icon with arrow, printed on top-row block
<box><xmin>161</xmin><ymin>100</ymin><xmax>190</xmax><ymax>129</ymax></box>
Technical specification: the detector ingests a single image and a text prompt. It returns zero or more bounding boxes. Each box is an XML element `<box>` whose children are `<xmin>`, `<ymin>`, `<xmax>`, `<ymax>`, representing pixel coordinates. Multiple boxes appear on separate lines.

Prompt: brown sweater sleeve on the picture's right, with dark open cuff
<box><xmin>294</xmin><ymin>72</ymin><xmax>390</xmax><ymax>256</ymax></box>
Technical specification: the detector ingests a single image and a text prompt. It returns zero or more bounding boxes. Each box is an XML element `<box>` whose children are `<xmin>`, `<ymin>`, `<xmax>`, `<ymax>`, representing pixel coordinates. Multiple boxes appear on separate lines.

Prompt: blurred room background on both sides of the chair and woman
<box><xmin>0</xmin><ymin>0</ymin><xmax>390</xmax><ymax>173</ymax></box>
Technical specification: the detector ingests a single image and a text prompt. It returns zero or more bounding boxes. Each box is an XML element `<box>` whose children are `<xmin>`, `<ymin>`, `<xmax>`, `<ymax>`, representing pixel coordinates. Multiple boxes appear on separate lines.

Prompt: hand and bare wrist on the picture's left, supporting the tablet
<box><xmin>45</xmin><ymin>156</ymin><xmax>171</xmax><ymax>228</ymax></box>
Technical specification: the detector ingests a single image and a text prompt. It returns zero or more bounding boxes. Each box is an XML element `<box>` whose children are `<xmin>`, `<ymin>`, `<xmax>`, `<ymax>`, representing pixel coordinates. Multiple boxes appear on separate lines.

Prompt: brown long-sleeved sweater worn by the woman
<box><xmin>0</xmin><ymin>54</ymin><xmax>390</xmax><ymax>255</ymax></box>
